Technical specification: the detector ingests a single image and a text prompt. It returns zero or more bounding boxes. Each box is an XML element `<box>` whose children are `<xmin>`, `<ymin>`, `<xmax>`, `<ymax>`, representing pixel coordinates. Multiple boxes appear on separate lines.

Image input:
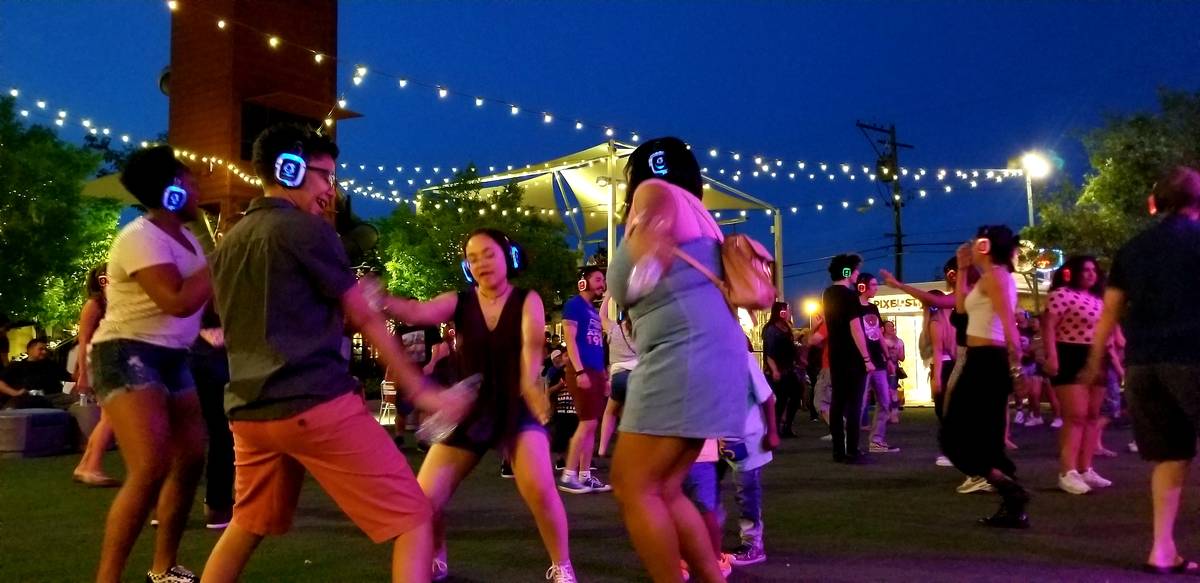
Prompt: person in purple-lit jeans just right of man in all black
<box><xmin>854</xmin><ymin>274</ymin><xmax>900</xmax><ymax>453</ymax></box>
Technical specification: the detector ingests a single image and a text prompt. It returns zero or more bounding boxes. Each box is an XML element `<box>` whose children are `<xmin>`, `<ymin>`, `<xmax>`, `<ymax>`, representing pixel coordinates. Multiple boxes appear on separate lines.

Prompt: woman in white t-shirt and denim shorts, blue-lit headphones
<box><xmin>88</xmin><ymin>146</ymin><xmax>212</xmax><ymax>583</ymax></box>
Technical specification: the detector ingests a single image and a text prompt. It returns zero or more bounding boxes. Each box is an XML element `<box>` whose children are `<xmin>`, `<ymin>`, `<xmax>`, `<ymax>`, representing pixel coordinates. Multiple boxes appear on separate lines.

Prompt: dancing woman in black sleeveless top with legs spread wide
<box><xmin>385</xmin><ymin>229</ymin><xmax>576</xmax><ymax>583</ymax></box>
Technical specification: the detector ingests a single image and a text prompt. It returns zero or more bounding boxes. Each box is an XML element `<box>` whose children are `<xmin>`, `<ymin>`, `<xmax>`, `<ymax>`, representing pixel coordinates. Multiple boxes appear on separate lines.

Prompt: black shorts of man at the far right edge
<box><xmin>1126</xmin><ymin>365</ymin><xmax>1200</xmax><ymax>462</ymax></box>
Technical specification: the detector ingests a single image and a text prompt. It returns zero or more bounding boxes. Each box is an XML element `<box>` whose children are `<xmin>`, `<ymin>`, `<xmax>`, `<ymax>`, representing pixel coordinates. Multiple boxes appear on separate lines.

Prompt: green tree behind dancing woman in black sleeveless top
<box><xmin>376</xmin><ymin>164</ymin><xmax>578</xmax><ymax>307</ymax></box>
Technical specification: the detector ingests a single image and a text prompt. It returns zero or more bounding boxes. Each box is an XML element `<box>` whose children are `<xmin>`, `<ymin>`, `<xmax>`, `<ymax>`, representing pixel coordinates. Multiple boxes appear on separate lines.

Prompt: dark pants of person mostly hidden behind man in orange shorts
<box><xmin>192</xmin><ymin>351</ymin><xmax>234</xmax><ymax>510</ymax></box>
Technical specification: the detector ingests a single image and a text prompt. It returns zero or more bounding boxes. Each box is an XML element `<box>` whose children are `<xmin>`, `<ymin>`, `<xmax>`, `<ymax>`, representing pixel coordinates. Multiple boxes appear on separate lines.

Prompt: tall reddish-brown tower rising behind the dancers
<box><xmin>168</xmin><ymin>0</ymin><xmax>355</xmax><ymax>232</ymax></box>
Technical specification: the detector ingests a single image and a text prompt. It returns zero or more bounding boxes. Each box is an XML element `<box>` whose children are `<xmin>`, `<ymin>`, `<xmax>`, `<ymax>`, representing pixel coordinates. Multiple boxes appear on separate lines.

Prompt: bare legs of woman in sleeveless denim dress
<box><xmin>612</xmin><ymin>433</ymin><xmax>724</xmax><ymax>583</ymax></box>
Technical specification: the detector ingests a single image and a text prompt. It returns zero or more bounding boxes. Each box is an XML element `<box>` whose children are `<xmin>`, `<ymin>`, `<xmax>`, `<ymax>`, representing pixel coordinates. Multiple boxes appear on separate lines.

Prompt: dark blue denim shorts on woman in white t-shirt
<box><xmin>88</xmin><ymin>339</ymin><xmax>196</xmax><ymax>402</ymax></box>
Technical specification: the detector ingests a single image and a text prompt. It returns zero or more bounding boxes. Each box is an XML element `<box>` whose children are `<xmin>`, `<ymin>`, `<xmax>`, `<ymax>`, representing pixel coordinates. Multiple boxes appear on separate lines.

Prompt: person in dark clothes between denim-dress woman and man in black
<box><xmin>762</xmin><ymin>301</ymin><xmax>804</xmax><ymax>438</ymax></box>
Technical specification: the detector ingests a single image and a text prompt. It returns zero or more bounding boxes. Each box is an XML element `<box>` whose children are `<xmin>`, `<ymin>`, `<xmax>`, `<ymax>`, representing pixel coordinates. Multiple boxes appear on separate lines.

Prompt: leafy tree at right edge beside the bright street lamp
<box><xmin>1022</xmin><ymin>90</ymin><xmax>1200</xmax><ymax>259</ymax></box>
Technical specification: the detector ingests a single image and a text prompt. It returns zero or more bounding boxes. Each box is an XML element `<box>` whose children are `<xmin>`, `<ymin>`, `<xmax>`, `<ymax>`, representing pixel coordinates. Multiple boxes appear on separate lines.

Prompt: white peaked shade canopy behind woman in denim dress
<box><xmin>422</xmin><ymin>140</ymin><xmax>784</xmax><ymax>294</ymax></box>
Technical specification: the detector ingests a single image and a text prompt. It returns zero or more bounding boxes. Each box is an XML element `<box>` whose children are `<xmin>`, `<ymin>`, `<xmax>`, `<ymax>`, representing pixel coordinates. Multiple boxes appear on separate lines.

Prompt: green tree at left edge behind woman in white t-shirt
<box><xmin>0</xmin><ymin>98</ymin><xmax>120</xmax><ymax>329</ymax></box>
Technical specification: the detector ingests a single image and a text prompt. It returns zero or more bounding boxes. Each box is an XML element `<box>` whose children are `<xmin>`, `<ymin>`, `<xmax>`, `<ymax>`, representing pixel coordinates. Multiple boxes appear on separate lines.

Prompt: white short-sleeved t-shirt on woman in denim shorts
<box><xmin>91</xmin><ymin>216</ymin><xmax>208</xmax><ymax>348</ymax></box>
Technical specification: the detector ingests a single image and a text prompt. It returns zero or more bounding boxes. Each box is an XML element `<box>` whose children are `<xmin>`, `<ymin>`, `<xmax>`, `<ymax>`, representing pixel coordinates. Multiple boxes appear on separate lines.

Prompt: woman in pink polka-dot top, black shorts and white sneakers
<box><xmin>1043</xmin><ymin>256</ymin><xmax>1112</xmax><ymax>494</ymax></box>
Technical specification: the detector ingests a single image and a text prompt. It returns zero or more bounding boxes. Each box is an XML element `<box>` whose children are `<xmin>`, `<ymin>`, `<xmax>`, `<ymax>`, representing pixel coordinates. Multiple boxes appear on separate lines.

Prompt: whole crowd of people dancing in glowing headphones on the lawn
<box><xmin>9</xmin><ymin>120</ymin><xmax>1200</xmax><ymax>583</ymax></box>
